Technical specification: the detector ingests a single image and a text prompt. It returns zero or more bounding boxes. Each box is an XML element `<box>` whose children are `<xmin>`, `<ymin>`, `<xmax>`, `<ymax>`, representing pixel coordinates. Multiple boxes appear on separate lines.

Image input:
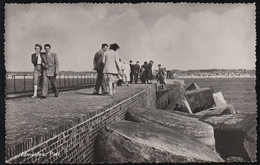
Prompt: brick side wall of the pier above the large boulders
<box><xmin>6</xmin><ymin>85</ymin><xmax>156</xmax><ymax>163</ymax></box>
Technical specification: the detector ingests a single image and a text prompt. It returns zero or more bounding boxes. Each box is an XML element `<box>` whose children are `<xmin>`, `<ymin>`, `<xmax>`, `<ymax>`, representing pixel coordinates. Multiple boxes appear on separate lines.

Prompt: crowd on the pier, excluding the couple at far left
<box><xmin>93</xmin><ymin>43</ymin><xmax>167</xmax><ymax>95</ymax></box>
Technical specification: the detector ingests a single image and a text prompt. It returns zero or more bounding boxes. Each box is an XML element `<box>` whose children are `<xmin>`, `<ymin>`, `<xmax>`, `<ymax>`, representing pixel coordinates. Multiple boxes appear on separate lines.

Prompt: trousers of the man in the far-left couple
<box><xmin>42</xmin><ymin>74</ymin><xmax>59</xmax><ymax>97</ymax></box>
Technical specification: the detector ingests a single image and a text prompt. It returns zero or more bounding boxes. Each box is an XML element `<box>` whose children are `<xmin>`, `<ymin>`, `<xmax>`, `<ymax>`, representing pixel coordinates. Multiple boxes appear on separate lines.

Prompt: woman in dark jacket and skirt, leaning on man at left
<box><xmin>31</xmin><ymin>44</ymin><xmax>47</xmax><ymax>99</ymax></box>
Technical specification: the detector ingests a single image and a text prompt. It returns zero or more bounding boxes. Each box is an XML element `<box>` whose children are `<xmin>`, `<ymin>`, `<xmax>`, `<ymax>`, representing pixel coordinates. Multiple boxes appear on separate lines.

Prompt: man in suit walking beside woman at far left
<box><xmin>42</xmin><ymin>44</ymin><xmax>59</xmax><ymax>98</ymax></box>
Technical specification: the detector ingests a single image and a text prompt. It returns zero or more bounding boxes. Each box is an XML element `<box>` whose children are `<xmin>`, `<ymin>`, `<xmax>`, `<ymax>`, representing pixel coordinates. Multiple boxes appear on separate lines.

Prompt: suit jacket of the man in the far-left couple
<box><xmin>46</xmin><ymin>53</ymin><xmax>59</xmax><ymax>76</ymax></box>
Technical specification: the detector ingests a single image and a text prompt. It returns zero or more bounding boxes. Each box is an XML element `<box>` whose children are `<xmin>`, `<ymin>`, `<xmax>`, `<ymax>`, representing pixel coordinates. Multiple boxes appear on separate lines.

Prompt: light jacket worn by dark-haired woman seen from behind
<box><xmin>103</xmin><ymin>49</ymin><xmax>121</xmax><ymax>74</ymax></box>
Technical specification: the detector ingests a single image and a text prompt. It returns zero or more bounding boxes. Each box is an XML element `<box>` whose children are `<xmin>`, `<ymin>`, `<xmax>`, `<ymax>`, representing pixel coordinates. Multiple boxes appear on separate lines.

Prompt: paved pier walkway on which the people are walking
<box><xmin>5</xmin><ymin>84</ymin><xmax>154</xmax><ymax>147</ymax></box>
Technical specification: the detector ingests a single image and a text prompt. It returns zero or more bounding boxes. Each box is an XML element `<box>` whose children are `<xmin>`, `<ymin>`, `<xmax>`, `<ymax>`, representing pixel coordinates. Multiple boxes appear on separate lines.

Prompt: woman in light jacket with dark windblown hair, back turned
<box><xmin>103</xmin><ymin>43</ymin><xmax>122</xmax><ymax>95</ymax></box>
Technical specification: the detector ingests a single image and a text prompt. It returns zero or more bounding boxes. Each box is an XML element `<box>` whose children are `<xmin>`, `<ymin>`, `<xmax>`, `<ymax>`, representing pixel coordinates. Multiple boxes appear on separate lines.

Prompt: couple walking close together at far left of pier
<box><xmin>31</xmin><ymin>44</ymin><xmax>59</xmax><ymax>99</ymax></box>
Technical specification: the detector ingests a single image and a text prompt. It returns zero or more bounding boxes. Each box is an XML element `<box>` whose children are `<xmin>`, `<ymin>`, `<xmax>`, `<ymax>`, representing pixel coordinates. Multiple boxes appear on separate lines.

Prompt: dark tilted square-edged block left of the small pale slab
<box><xmin>185</xmin><ymin>88</ymin><xmax>215</xmax><ymax>113</ymax></box>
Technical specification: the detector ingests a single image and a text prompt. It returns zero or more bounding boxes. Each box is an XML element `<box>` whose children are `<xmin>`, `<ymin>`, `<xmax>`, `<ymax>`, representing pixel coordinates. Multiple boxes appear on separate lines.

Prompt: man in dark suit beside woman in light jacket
<box><xmin>93</xmin><ymin>44</ymin><xmax>108</xmax><ymax>95</ymax></box>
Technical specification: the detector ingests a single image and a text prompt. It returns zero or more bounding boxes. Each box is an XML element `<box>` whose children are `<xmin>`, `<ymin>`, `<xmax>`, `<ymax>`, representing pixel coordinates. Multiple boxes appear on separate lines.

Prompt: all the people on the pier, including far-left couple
<box><xmin>31</xmin><ymin>43</ymin><xmax>167</xmax><ymax>99</ymax></box>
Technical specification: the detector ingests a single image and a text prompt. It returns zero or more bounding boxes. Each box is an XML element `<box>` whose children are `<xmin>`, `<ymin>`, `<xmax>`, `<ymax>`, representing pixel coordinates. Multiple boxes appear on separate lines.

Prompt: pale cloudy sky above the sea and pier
<box><xmin>5</xmin><ymin>3</ymin><xmax>256</xmax><ymax>71</ymax></box>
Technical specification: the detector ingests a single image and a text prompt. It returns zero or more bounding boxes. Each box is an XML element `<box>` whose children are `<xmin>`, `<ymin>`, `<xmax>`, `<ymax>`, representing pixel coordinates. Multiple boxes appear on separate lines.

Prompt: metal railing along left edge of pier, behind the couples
<box><xmin>6</xmin><ymin>72</ymin><xmax>97</xmax><ymax>94</ymax></box>
